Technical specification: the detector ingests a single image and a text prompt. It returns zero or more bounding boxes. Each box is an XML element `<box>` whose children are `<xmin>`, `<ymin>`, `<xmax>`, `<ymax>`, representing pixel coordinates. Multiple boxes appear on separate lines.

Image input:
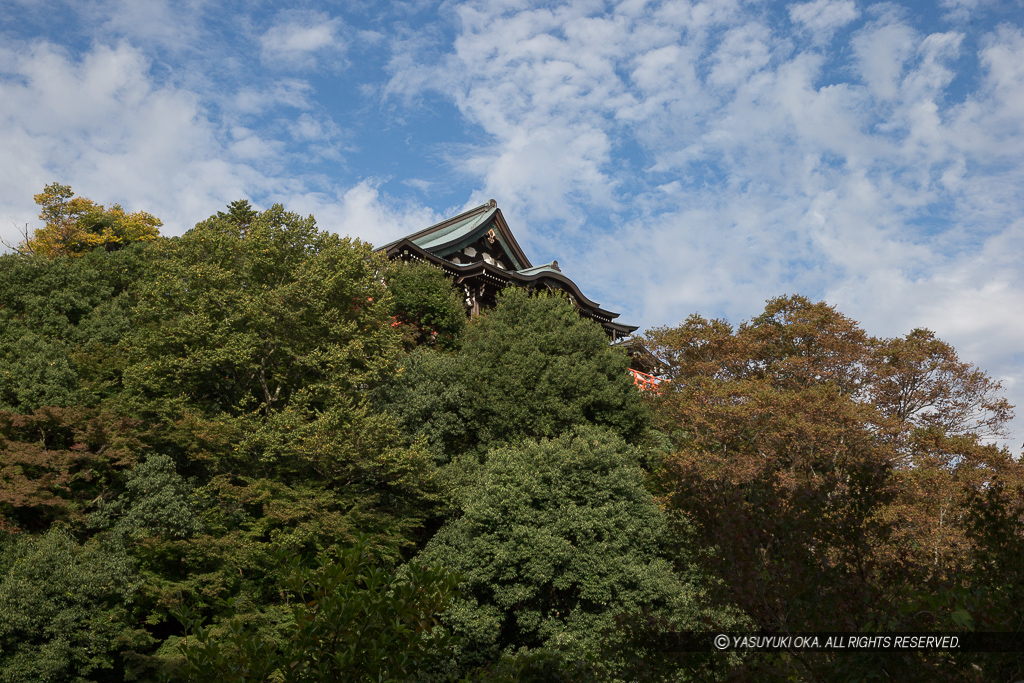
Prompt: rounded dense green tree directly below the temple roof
<box><xmin>379</xmin><ymin>288</ymin><xmax>647</xmax><ymax>459</ymax></box>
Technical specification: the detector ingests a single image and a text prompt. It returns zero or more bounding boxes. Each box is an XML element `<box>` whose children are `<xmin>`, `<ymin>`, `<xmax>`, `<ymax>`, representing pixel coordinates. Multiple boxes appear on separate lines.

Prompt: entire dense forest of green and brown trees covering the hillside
<box><xmin>0</xmin><ymin>184</ymin><xmax>1024</xmax><ymax>683</ymax></box>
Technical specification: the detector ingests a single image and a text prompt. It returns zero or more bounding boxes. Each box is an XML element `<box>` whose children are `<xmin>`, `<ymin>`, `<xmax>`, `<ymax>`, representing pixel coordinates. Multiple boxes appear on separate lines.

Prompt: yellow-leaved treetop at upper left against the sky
<box><xmin>19</xmin><ymin>182</ymin><xmax>163</xmax><ymax>258</ymax></box>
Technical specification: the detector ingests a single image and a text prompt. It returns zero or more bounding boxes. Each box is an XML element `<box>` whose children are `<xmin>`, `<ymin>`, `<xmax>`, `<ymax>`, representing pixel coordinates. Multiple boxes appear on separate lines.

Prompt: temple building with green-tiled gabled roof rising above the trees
<box><xmin>378</xmin><ymin>200</ymin><xmax>637</xmax><ymax>342</ymax></box>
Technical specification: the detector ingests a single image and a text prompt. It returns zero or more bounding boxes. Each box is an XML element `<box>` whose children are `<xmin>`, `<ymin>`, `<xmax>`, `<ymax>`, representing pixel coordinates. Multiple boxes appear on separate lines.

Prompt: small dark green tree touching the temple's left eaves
<box><xmin>385</xmin><ymin>260</ymin><xmax>466</xmax><ymax>350</ymax></box>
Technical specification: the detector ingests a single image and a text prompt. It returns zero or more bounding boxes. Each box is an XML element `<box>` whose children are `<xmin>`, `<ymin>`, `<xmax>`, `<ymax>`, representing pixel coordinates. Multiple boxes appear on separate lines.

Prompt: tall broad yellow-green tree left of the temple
<box><xmin>91</xmin><ymin>206</ymin><xmax>446</xmax><ymax>666</ymax></box>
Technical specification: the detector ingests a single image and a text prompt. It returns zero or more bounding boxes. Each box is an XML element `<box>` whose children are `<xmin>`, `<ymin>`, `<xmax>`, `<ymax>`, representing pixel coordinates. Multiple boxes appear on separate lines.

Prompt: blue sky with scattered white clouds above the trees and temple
<box><xmin>6</xmin><ymin>0</ymin><xmax>1024</xmax><ymax>454</ymax></box>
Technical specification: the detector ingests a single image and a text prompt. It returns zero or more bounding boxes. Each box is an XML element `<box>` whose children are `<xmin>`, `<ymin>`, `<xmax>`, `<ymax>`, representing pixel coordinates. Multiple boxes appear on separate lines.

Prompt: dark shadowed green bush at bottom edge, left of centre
<box><xmin>176</xmin><ymin>539</ymin><xmax>458</xmax><ymax>683</ymax></box>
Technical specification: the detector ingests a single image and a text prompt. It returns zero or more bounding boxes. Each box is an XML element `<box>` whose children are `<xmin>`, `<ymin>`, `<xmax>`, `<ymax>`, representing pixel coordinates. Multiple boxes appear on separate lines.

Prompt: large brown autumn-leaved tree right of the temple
<box><xmin>648</xmin><ymin>296</ymin><xmax>1024</xmax><ymax>676</ymax></box>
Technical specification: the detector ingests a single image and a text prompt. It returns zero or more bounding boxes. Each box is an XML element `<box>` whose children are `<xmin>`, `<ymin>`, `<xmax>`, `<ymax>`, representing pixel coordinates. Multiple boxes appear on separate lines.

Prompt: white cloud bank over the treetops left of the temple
<box><xmin>0</xmin><ymin>38</ymin><xmax>428</xmax><ymax>254</ymax></box>
